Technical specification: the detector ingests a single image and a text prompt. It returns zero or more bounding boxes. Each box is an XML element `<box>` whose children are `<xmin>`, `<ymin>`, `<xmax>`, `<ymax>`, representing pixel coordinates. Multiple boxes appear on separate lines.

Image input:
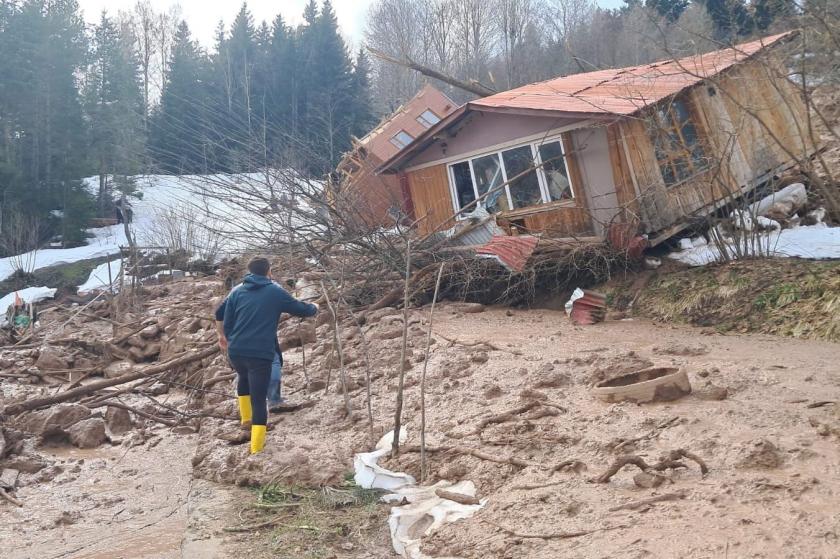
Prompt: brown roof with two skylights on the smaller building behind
<box><xmin>359</xmin><ymin>84</ymin><xmax>457</xmax><ymax>161</ymax></box>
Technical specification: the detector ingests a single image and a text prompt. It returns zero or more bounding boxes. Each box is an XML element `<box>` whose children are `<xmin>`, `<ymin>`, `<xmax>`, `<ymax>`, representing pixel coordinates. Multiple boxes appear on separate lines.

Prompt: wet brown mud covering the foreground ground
<box><xmin>0</xmin><ymin>304</ymin><xmax>840</xmax><ymax>559</ymax></box>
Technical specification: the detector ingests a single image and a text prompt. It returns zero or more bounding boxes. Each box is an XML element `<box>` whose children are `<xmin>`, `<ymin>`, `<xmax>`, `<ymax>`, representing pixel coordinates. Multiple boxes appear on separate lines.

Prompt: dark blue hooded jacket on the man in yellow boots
<box><xmin>216</xmin><ymin>274</ymin><xmax>318</xmax><ymax>361</ymax></box>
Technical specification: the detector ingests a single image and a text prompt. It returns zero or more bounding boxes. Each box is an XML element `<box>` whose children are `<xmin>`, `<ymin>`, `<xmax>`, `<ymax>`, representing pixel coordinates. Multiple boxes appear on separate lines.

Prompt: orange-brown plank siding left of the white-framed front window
<box><xmin>406</xmin><ymin>164</ymin><xmax>455</xmax><ymax>235</ymax></box>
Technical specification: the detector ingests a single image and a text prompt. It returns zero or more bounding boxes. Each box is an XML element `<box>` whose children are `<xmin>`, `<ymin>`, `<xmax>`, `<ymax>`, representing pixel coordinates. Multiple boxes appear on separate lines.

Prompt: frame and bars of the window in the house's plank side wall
<box><xmin>649</xmin><ymin>95</ymin><xmax>710</xmax><ymax>189</ymax></box>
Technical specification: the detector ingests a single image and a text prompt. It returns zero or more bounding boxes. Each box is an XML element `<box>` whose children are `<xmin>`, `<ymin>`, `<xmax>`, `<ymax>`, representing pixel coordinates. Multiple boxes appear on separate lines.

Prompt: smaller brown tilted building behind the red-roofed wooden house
<box><xmin>338</xmin><ymin>85</ymin><xmax>457</xmax><ymax>227</ymax></box>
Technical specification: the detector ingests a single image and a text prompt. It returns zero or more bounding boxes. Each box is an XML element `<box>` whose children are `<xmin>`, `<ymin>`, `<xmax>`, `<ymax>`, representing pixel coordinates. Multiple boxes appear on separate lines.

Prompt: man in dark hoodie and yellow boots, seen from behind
<box><xmin>217</xmin><ymin>257</ymin><xmax>318</xmax><ymax>454</ymax></box>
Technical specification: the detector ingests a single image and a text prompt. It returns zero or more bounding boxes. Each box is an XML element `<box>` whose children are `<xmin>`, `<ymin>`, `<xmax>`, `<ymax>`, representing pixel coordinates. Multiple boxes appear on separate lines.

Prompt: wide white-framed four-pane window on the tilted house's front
<box><xmin>449</xmin><ymin>138</ymin><xmax>574</xmax><ymax>213</ymax></box>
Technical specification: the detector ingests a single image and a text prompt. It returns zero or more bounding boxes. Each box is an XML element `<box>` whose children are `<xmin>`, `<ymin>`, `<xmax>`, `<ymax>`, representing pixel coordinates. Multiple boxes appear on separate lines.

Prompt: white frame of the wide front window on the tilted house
<box><xmin>446</xmin><ymin>133</ymin><xmax>578</xmax><ymax>219</ymax></box>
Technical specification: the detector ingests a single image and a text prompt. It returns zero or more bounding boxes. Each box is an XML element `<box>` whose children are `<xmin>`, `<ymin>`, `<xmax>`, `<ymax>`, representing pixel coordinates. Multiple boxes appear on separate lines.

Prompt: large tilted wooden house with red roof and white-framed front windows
<box><xmin>378</xmin><ymin>33</ymin><xmax>814</xmax><ymax>244</ymax></box>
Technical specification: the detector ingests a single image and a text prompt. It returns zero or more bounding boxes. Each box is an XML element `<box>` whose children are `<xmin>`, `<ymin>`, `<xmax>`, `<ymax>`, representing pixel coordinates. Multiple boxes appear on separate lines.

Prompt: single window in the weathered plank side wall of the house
<box><xmin>650</xmin><ymin>99</ymin><xmax>707</xmax><ymax>186</ymax></box>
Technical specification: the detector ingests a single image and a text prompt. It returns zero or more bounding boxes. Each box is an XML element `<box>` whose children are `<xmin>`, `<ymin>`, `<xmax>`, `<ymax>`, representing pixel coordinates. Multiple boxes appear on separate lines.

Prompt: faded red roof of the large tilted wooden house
<box><xmin>378</xmin><ymin>31</ymin><xmax>796</xmax><ymax>172</ymax></box>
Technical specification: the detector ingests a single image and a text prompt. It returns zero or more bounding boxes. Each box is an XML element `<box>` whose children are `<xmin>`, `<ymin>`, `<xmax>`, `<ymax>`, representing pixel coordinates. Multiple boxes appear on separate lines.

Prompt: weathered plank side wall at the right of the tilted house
<box><xmin>613</xmin><ymin>53</ymin><xmax>813</xmax><ymax>232</ymax></box>
